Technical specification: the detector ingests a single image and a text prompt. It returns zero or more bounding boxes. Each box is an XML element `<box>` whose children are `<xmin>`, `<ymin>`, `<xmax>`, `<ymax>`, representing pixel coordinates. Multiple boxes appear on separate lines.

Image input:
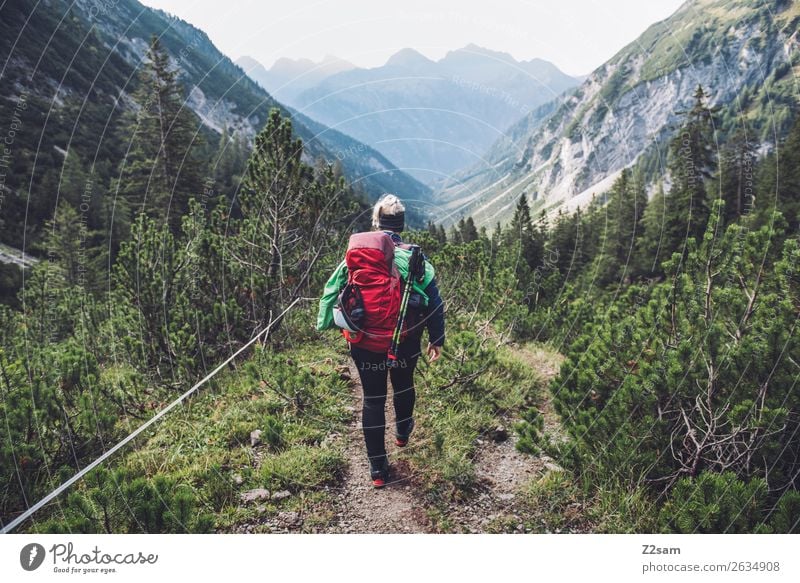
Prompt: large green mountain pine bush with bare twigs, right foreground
<box><xmin>551</xmin><ymin>204</ymin><xmax>800</xmax><ymax>532</ymax></box>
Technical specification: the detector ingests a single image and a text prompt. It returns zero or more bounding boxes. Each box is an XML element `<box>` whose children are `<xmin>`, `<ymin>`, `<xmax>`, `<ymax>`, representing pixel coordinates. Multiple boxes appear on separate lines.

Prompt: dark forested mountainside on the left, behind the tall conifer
<box><xmin>0</xmin><ymin>0</ymin><xmax>428</xmax><ymax>258</ymax></box>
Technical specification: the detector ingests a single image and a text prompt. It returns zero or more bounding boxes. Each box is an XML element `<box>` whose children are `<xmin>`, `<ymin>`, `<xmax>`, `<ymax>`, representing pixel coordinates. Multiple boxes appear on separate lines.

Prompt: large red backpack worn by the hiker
<box><xmin>337</xmin><ymin>231</ymin><xmax>401</xmax><ymax>353</ymax></box>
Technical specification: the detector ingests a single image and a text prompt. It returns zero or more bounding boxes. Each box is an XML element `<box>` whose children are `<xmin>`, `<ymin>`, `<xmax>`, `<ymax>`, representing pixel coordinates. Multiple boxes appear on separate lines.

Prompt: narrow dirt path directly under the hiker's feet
<box><xmin>328</xmin><ymin>362</ymin><xmax>430</xmax><ymax>533</ymax></box>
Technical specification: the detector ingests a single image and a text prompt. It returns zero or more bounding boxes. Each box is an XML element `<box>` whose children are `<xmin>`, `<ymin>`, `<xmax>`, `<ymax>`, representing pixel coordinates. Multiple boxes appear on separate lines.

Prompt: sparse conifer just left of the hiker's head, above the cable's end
<box><xmin>234</xmin><ymin>108</ymin><xmax>358</xmax><ymax>331</ymax></box>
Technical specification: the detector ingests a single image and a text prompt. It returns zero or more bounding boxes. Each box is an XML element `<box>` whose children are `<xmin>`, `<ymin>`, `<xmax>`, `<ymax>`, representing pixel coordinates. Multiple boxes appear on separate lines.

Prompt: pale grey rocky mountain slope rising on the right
<box><xmin>436</xmin><ymin>0</ymin><xmax>800</xmax><ymax>224</ymax></box>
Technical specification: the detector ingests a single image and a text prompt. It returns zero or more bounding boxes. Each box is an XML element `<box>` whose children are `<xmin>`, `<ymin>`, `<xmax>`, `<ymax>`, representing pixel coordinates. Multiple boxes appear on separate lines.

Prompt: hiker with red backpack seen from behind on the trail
<box><xmin>317</xmin><ymin>194</ymin><xmax>445</xmax><ymax>488</ymax></box>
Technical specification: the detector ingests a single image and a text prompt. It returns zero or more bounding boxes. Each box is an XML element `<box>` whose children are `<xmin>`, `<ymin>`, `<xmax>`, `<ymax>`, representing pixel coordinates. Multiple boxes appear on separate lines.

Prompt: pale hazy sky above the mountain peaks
<box><xmin>144</xmin><ymin>0</ymin><xmax>683</xmax><ymax>75</ymax></box>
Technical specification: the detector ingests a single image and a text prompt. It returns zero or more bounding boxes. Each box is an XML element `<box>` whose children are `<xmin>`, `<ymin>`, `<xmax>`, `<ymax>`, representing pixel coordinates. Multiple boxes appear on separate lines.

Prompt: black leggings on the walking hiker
<box><xmin>350</xmin><ymin>336</ymin><xmax>420</xmax><ymax>465</ymax></box>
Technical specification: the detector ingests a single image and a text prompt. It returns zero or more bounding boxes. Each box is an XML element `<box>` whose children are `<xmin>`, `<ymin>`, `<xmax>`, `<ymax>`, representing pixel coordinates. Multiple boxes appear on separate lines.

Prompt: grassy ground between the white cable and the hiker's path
<box><xmin>33</xmin><ymin>341</ymin><xmax>352</xmax><ymax>532</ymax></box>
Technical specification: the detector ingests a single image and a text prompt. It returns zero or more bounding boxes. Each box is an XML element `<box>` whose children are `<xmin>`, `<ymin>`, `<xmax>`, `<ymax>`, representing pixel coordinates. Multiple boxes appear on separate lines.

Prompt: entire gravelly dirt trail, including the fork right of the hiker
<box><xmin>231</xmin><ymin>346</ymin><xmax>563</xmax><ymax>534</ymax></box>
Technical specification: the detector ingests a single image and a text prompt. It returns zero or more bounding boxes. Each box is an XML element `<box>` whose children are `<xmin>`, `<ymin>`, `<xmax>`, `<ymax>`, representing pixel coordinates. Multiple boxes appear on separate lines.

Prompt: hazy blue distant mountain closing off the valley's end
<box><xmin>247</xmin><ymin>44</ymin><xmax>578</xmax><ymax>185</ymax></box>
